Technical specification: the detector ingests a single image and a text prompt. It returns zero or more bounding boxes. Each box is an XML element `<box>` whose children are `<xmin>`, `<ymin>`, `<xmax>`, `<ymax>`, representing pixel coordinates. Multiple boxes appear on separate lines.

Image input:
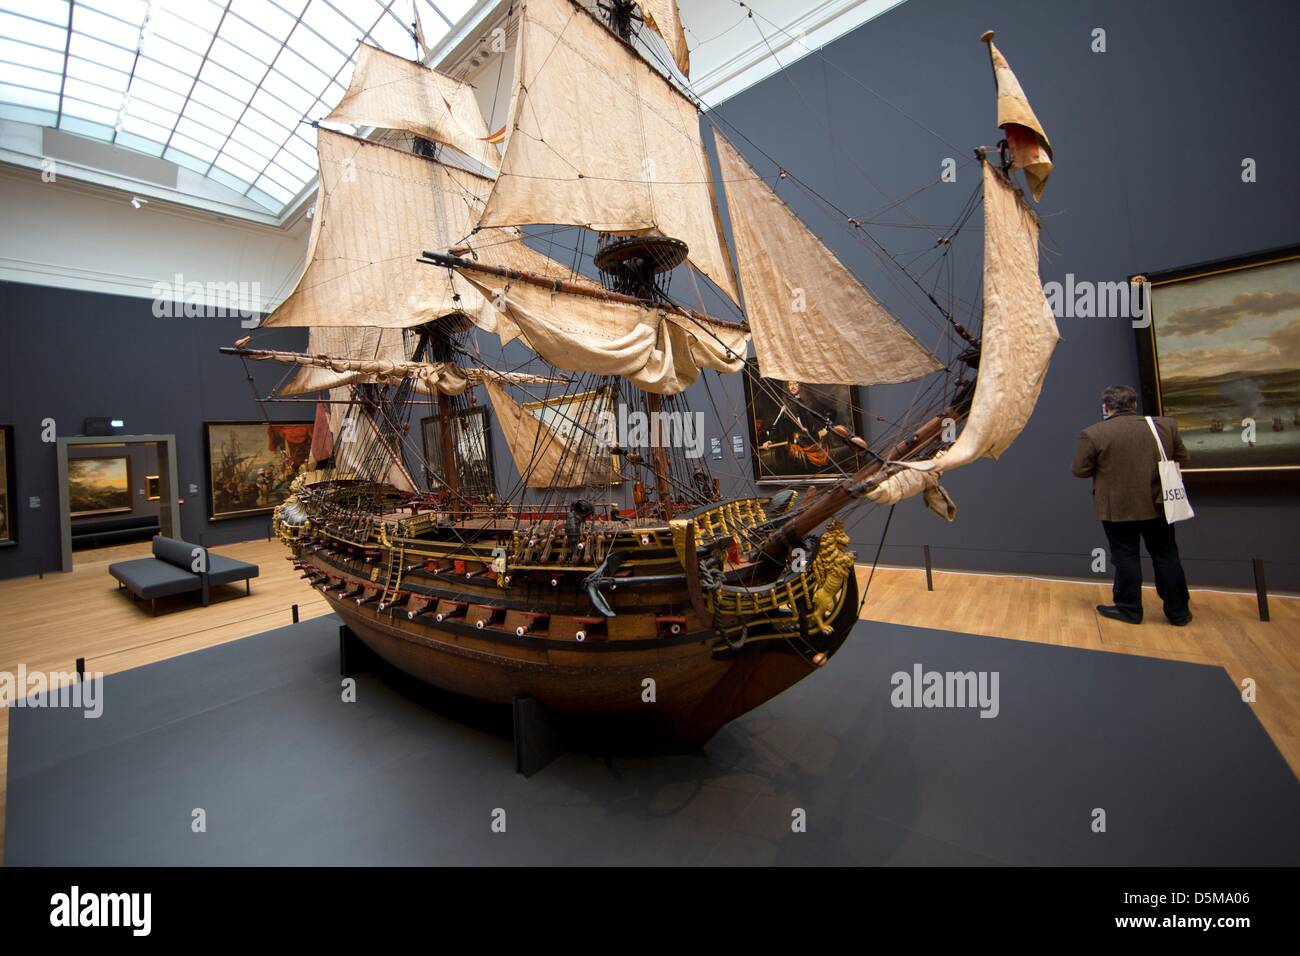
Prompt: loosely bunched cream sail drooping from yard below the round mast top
<box><xmin>462</xmin><ymin>269</ymin><xmax>745</xmax><ymax>395</ymax></box>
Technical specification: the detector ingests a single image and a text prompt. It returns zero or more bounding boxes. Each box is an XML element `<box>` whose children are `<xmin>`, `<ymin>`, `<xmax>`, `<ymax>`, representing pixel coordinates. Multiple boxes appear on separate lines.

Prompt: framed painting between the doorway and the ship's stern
<box><xmin>203</xmin><ymin>421</ymin><xmax>312</xmax><ymax>522</ymax></box>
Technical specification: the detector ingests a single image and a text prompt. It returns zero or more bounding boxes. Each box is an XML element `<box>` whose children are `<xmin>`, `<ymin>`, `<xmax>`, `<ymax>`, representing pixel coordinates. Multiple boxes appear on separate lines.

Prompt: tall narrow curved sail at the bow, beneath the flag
<box><xmin>868</xmin><ymin>161</ymin><xmax>1061</xmax><ymax>501</ymax></box>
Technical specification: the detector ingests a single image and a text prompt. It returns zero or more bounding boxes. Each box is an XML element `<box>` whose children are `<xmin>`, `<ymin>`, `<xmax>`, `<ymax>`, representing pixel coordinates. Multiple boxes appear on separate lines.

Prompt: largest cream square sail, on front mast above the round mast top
<box><xmin>481</xmin><ymin>0</ymin><xmax>738</xmax><ymax>302</ymax></box>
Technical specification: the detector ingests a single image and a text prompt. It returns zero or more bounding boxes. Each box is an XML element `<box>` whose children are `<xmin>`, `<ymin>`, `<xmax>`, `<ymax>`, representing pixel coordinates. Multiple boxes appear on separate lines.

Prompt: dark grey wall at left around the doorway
<box><xmin>0</xmin><ymin>282</ymin><xmax>306</xmax><ymax>578</ymax></box>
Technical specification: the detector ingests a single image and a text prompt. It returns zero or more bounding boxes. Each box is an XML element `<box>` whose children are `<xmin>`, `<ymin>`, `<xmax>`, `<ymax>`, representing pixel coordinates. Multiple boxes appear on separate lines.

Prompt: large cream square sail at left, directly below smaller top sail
<box><xmin>263</xmin><ymin>130</ymin><xmax>608</xmax><ymax>335</ymax></box>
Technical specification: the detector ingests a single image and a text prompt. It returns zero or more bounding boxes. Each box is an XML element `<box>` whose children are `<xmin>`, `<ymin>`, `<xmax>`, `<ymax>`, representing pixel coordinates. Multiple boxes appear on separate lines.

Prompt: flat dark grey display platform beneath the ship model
<box><xmin>5</xmin><ymin>617</ymin><xmax>1300</xmax><ymax>865</ymax></box>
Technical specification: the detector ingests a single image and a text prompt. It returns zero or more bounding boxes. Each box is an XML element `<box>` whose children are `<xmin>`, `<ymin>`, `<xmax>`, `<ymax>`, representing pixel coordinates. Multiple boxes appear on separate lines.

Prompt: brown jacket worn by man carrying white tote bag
<box><xmin>1073</xmin><ymin>411</ymin><xmax>1191</xmax><ymax>522</ymax></box>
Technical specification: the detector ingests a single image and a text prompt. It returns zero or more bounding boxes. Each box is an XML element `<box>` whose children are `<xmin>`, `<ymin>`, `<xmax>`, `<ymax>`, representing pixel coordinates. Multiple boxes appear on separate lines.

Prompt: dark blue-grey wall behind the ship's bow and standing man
<box><xmin>702</xmin><ymin>0</ymin><xmax>1300</xmax><ymax>591</ymax></box>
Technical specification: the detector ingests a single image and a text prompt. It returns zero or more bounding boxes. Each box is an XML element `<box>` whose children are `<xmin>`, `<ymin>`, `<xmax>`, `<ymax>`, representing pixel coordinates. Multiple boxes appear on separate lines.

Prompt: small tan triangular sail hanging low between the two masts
<box><xmin>486</xmin><ymin>381</ymin><xmax>615</xmax><ymax>488</ymax></box>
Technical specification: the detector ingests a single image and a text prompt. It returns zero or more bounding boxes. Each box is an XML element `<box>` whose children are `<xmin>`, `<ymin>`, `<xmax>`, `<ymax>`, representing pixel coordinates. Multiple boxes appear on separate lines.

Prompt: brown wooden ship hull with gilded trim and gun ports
<box><xmin>274</xmin><ymin>481</ymin><xmax>858</xmax><ymax>745</ymax></box>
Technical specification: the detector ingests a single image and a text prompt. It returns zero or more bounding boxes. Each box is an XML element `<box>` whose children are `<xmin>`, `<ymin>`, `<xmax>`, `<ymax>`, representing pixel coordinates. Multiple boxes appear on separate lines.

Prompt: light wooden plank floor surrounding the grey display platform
<box><xmin>0</xmin><ymin>541</ymin><xmax>1300</xmax><ymax>853</ymax></box>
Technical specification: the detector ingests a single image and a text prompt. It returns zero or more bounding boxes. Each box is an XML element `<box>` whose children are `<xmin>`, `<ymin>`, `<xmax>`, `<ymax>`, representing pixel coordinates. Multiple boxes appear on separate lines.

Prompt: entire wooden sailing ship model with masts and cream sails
<box><xmin>224</xmin><ymin>0</ymin><xmax>1057</xmax><ymax>745</ymax></box>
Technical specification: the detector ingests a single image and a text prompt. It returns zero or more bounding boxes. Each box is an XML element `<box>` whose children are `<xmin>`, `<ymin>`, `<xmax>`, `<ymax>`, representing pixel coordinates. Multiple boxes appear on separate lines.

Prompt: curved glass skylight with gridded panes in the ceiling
<box><xmin>0</xmin><ymin>0</ymin><xmax>473</xmax><ymax>215</ymax></box>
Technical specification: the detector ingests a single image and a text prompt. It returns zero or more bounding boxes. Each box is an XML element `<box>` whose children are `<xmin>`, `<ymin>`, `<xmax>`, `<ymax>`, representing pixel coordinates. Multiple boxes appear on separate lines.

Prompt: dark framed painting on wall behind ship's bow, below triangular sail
<box><xmin>745</xmin><ymin>360</ymin><xmax>863</xmax><ymax>483</ymax></box>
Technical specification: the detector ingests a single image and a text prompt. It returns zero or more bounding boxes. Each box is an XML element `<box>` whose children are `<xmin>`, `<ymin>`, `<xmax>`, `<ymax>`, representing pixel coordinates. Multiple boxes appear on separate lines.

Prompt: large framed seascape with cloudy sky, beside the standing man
<box><xmin>1138</xmin><ymin>246</ymin><xmax>1300</xmax><ymax>472</ymax></box>
